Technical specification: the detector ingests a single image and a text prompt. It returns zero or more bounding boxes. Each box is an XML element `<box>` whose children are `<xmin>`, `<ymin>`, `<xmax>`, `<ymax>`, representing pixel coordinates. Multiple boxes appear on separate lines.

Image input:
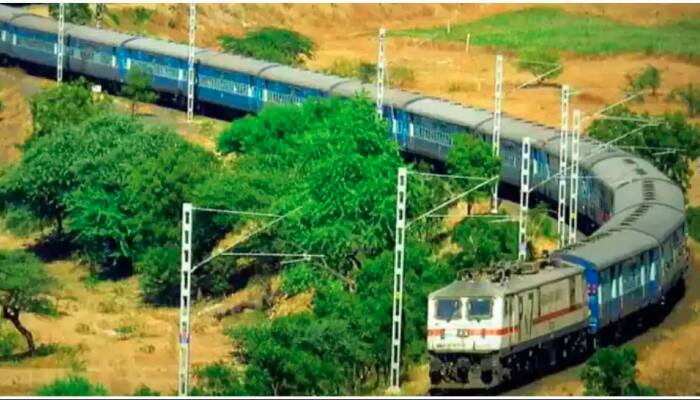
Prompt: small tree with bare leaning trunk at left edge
<box><xmin>0</xmin><ymin>250</ymin><xmax>53</xmax><ymax>355</ymax></box>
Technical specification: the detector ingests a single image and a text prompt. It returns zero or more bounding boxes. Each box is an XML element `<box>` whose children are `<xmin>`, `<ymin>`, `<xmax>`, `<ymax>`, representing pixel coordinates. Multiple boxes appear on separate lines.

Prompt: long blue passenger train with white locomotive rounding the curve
<box><xmin>0</xmin><ymin>6</ymin><xmax>688</xmax><ymax>388</ymax></box>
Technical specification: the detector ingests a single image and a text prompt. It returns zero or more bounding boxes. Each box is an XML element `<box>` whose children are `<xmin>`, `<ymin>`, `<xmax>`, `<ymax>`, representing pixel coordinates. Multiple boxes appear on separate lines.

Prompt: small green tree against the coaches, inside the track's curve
<box><xmin>447</xmin><ymin>134</ymin><xmax>501</xmax><ymax>214</ymax></box>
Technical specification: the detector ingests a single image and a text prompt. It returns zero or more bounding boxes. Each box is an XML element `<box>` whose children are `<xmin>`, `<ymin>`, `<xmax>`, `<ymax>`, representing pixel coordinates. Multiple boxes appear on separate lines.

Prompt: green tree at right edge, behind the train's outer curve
<box><xmin>588</xmin><ymin>107</ymin><xmax>700</xmax><ymax>191</ymax></box>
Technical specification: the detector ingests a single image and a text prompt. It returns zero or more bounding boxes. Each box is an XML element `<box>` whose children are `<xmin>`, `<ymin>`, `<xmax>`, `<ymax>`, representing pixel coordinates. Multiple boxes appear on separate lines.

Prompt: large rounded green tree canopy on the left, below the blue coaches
<box><xmin>0</xmin><ymin>113</ymin><xmax>219</xmax><ymax>282</ymax></box>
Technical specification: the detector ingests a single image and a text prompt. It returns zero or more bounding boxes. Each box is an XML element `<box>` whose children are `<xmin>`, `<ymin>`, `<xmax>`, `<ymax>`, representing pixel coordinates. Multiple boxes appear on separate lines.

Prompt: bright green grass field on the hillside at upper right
<box><xmin>390</xmin><ymin>7</ymin><xmax>700</xmax><ymax>58</ymax></box>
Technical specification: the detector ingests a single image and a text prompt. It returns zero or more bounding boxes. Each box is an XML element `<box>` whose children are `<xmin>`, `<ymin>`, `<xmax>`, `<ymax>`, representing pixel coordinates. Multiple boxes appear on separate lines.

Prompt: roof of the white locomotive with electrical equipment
<box><xmin>430</xmin><ymin>266</ymin><xmax>582</xmax><ymax>299</ymax></box>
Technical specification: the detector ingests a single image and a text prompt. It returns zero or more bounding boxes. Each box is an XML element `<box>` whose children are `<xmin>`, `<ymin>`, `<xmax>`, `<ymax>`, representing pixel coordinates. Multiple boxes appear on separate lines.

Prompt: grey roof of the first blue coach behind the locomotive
<box><xmin>555</xmin><ymin>225</ymin><xmax>658</xmax><ymax>270</ymax></box>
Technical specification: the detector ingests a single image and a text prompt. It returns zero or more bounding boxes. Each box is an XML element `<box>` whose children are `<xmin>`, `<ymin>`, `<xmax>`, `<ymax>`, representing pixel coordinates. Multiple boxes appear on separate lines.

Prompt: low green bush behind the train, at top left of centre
<box><xmin>219</xmin><ymin>27</ymin><xmax>316</xmax><ymax>65</ymax></box>
